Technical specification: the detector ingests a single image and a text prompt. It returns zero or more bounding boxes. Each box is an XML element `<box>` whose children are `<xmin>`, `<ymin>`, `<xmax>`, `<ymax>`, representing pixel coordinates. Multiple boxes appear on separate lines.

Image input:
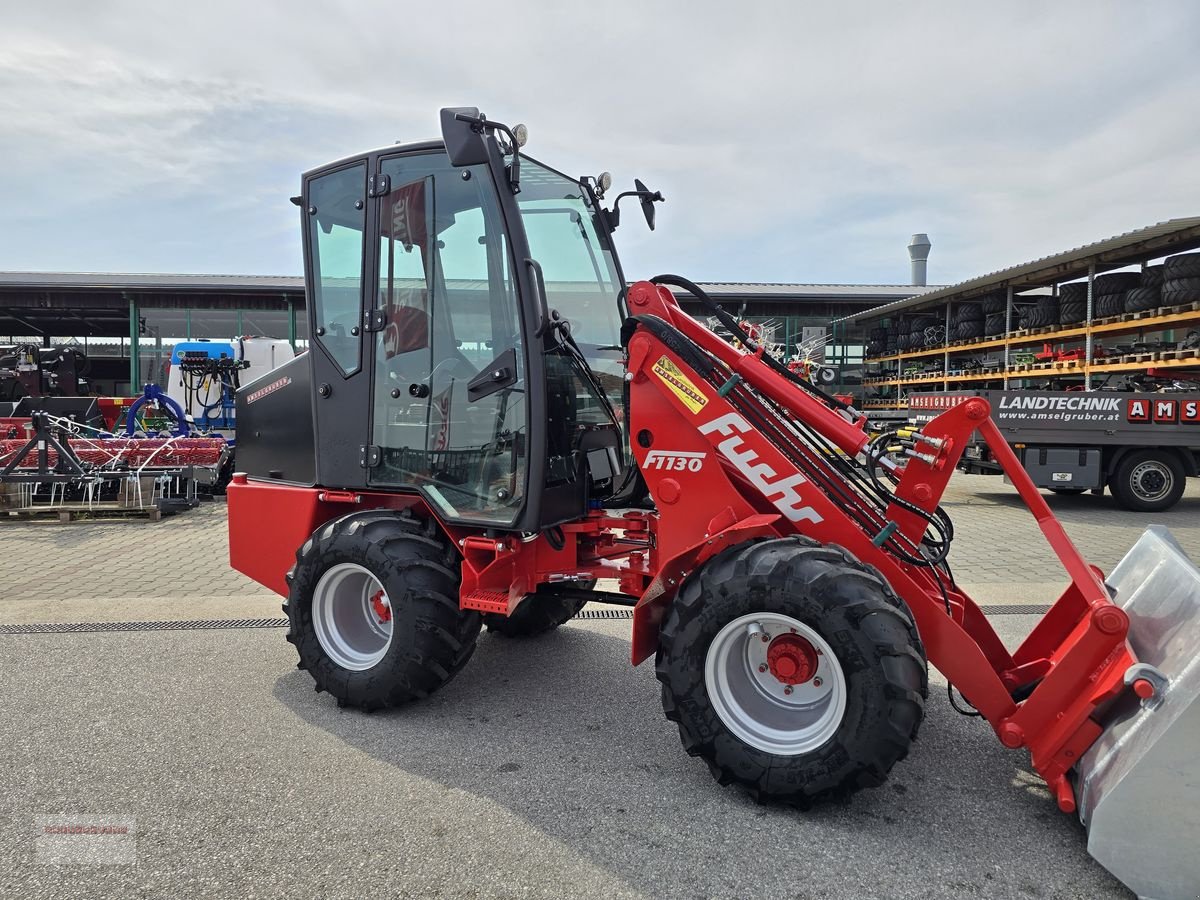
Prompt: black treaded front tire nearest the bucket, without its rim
<box><xmin>655</xmin><ymin>536</ymin><xmax>929</xmax><ymax>809</ymax></box>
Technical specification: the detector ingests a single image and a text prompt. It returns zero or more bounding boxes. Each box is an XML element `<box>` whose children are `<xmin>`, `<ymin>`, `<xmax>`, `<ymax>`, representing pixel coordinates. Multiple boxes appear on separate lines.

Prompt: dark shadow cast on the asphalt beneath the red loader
<box><xmin>274</xmin><ymin>625</ymin><xmax>1129</xmax><ymax>898</ymax></box>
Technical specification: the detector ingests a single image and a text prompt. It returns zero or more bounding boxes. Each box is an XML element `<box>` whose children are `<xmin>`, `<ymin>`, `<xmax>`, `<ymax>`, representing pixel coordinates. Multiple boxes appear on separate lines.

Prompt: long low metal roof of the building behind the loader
<box><xmin>0</xmin><ymin>272</ymin><xmax>936</xmax><ymax>302</ymax></box>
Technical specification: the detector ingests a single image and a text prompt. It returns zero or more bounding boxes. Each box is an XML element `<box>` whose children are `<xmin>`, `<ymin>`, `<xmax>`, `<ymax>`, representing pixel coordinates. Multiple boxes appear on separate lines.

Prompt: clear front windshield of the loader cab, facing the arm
<box><xmin>517</xmin><ymin>163</ymin><xmax>624</xmax><ymax>409</ymax></box>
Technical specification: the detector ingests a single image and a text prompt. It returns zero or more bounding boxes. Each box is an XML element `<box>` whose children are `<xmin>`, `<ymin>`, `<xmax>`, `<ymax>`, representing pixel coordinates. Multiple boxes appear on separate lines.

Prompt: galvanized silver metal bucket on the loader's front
<box><xmin>1075</xmin><ymin>526</ymin><xmax>1200</xmax><ymax>900</ymax></box>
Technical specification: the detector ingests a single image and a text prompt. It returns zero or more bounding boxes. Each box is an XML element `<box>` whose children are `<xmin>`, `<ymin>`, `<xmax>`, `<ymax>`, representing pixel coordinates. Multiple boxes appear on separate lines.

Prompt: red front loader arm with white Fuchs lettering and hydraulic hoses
<box><xmin>629</xmin><ymin>282</ymin><xmax>1148</xmax><ymax>811</ymax></box>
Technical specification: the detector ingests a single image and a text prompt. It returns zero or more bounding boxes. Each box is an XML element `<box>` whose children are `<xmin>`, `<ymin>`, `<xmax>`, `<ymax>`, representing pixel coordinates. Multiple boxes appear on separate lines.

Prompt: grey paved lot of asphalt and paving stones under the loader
<box><xmin>0</xmin><ymin>476</ymin><xmax>1200</xmax><ymax>900</ymax></box>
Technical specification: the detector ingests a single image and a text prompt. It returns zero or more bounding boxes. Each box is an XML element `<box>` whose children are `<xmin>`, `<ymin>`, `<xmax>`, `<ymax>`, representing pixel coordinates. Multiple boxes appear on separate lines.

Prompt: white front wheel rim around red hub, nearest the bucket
<box><xmin>704</xmin><ymin>612</ymin><xmax>847</xmax><ymax>756</ymax></box>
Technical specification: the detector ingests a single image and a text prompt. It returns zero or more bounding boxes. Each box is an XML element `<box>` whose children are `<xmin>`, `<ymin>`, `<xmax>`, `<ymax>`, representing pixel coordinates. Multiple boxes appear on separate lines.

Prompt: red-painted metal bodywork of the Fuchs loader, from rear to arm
<box><xmin>228</xmin><ymin>282</ymin><xmax>1136</xmax><ymax>810</ymax></box>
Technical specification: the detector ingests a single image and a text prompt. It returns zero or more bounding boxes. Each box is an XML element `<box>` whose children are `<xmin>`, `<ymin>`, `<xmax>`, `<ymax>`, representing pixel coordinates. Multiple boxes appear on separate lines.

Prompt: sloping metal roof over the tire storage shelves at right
<box><xmin>835</xmin><ymin>216</ymin><xmax>1200</xmax><ymax>323</ymax></box>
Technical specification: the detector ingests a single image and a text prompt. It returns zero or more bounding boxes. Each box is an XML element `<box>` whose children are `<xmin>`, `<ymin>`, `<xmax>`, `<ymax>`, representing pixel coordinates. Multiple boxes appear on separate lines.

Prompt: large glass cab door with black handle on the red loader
<box><xmin>368</xmin><ymin>151</ymin><xmax>528</xmax><ymax>527</ymax></box>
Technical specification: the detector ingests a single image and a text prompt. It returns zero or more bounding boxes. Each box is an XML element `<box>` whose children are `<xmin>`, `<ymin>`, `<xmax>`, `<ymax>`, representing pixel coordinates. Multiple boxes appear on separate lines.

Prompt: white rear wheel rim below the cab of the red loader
<box><xmin>312</xmin><ymin>563</ymin><xmax>392</xmax><ymax>672</ymax></box>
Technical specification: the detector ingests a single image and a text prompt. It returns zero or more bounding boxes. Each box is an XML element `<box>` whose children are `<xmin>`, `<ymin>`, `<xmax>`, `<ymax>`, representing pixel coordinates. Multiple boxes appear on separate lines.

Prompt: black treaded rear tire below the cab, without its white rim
<box><xmin>283</xmin><ymin>510</ymin><xmax>481</xmax><ymax>712</ymax></box>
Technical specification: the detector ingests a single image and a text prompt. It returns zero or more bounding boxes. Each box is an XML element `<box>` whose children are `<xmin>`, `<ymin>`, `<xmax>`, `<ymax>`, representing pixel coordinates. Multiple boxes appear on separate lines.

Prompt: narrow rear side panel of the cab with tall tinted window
<box><xmin>301</xmin><ymin>158</ymin><xmax>373</xmax><ymax>488</ymax></box>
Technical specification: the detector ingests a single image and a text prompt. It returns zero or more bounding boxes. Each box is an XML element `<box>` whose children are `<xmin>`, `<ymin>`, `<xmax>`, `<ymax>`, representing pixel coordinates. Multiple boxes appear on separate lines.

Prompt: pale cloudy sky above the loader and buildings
<box><xmin>0</xmin><ymin>0</ymin><xmax>1200</xmax><ymax>283</ymax></box>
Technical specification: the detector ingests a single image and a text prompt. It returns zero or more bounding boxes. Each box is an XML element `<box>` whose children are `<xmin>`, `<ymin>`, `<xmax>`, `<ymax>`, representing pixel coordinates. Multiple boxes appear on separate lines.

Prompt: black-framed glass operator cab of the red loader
<box><xmin>300</xmin><ymin>117</ymin><xmax>626</xmax><ymax>533</ymax></box>
